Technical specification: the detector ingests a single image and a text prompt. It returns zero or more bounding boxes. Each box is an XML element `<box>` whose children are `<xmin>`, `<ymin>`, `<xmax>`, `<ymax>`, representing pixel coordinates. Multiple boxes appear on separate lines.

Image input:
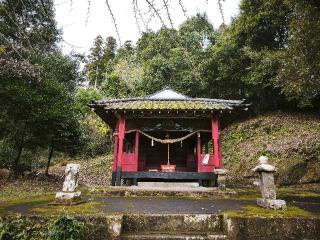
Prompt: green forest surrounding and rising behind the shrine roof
<box><xmin>0</xmin><ymin>0</ymin><xmax>320</xmax><ymax>175</ymax></box>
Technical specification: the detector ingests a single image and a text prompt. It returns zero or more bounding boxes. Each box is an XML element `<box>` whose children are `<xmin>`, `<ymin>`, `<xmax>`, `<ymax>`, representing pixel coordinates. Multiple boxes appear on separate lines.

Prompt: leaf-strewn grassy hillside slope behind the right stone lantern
<box><xmin>221</xmin><ymin>113</ymin><xmax>320</xmax><ymax>185</ymax></box>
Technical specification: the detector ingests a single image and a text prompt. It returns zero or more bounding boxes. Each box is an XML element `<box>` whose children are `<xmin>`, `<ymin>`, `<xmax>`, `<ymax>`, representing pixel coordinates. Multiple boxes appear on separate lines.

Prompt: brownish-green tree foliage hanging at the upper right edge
<box><xmin>278</xmin><ymin>0</ymin><xmax>320</xmax><ymax>107</ymax></box>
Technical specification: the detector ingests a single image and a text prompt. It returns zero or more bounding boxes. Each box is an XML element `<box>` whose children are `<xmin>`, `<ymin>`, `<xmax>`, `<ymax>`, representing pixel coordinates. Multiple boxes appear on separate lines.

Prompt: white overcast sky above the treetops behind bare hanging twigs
<box><xmin>54</xmin><ymin>0</ymin><xmax>240</xmax><ymax>53</ymax></box>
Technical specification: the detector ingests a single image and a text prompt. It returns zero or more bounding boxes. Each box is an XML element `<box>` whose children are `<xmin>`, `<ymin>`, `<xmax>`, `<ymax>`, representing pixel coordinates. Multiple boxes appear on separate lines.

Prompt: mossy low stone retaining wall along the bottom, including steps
<box><xmin>1</xmin><ymin>214</ymin><xmax>320</xmax><ymax>240</ymax></box>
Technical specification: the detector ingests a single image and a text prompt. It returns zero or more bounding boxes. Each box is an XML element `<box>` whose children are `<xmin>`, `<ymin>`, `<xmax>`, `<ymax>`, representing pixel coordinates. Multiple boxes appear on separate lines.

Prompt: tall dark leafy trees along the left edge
<box><xmin>0</xmin><ymin>0</ymin><xmax>78</xmax><ymax>173</ymax></box>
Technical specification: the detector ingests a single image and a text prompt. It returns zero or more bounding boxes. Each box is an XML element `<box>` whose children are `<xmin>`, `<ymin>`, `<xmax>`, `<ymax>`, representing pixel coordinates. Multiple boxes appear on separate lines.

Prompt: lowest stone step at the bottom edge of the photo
<box><xmin>120</xmin><ymin>232</ymin><xmax>227</xmax><ymax>240</ymax></box>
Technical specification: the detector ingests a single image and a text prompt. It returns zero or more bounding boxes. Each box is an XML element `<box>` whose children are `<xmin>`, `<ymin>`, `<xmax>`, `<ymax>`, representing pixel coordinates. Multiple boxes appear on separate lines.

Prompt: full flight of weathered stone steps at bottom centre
<box><xmin>120</xmin><ymin>214</ymin><xmax>227</xmax><ymax>240</ymax></box>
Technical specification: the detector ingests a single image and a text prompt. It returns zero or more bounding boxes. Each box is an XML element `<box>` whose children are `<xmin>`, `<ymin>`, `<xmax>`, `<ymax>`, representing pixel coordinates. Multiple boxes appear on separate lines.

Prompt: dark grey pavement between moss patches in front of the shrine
<box><xmin>6</xmin><ymin>197</ymin><xmax>320</xmax><ymax>214</ymax></box>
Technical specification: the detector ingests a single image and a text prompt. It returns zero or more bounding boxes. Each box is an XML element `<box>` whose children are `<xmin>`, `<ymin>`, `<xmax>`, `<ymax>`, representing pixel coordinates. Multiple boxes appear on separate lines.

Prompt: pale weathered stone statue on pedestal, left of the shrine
<box><xmin>56</xmin><ymin>164</ymin><xmax>81</xmax><ymax>204</ymax></box>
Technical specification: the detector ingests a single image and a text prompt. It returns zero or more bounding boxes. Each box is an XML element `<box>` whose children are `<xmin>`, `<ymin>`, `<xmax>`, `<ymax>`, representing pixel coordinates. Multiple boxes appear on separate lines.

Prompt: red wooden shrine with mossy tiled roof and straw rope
<box><xmin>91</xmin><ymin>89</ymin><xmax>246</xmax><ymax>185</ymax></box>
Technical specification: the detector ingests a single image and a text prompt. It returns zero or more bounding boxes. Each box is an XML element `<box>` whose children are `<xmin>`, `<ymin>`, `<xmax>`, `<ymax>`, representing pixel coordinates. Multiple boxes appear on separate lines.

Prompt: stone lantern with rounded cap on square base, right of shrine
<box><xmin>253</xmin><ymin>156</ymin><xmax>286</xmax><ymax>209</ymax></box>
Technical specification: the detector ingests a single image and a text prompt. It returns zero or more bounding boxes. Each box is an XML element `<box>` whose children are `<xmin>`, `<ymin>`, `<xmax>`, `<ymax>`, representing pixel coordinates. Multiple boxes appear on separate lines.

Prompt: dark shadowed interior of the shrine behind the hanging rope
<box><xmin>124</xmin><ymin>131</ymin><xmax>212</xmax><ymax>172</ymax></box>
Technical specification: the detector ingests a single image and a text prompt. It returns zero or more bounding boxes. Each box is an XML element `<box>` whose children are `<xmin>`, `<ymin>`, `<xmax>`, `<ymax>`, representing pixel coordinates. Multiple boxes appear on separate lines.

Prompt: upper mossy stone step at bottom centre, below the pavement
<box><xmin>122</xmin><ymin>214</ymin><xmax>224</xmax><ymax>234</ymax></box>
